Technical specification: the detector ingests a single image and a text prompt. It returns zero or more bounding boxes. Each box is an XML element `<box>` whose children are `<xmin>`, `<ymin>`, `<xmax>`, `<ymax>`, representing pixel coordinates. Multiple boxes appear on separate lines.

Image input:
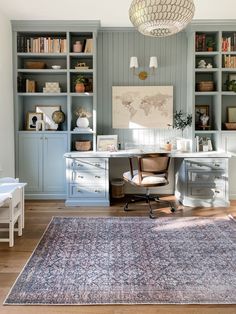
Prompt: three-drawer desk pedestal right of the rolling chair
<box><xmin>175</xmin><ymin>158</ymin><xmax>229</xmax><ymax>207</ymax></box>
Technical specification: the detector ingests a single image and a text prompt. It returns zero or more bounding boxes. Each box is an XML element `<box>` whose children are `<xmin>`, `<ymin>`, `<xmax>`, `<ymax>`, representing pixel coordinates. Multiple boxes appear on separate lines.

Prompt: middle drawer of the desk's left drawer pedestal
<box><xmin>71</xmin><ymin>171</ymin><xmax>106</xmax><ymax>186</ymax></box>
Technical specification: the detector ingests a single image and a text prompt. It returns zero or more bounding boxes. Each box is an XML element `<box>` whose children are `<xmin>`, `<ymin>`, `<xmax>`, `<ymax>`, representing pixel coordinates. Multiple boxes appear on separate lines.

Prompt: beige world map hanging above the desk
<box><xmin>112</xmin><ymin>86</ymin><xmax>173</xmax><ymax>129</ymax></box>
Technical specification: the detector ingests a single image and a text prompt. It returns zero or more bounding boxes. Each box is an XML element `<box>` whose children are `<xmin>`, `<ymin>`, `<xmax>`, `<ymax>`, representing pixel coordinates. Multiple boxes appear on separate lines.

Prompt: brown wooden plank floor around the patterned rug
<box><xmin>0</xmin><ymin>197</ymin><xmax>236</xmax><ymax>314</ymax></box>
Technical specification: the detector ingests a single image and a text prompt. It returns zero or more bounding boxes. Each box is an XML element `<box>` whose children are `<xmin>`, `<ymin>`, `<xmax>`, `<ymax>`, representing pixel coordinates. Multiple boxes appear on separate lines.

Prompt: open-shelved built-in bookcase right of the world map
<box><xmin>188</xmin><ymin>23</ymin><xmax>236</xmax><ymax>150</ymax></box>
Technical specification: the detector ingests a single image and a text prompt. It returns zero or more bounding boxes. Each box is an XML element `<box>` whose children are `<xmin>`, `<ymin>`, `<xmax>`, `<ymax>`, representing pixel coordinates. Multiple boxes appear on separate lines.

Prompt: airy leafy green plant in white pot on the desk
<box><xmin>173</xmin><ymin>110</ymin><xmax>193</xmax><ymax>152</ymax></box>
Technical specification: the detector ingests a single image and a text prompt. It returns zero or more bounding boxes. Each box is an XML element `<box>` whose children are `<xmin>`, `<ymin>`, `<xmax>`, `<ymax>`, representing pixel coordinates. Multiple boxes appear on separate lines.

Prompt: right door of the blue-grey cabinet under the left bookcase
<box><xmin>43</xmin><ymin>134</ymin><xmax>67</xmax><ymax>193</ymax></box>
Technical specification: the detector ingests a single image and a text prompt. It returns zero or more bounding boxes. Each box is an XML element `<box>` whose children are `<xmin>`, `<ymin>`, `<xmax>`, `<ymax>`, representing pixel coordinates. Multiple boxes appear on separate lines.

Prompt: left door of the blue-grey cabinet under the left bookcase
<box><xmin>19</xmin><ymin>134</ymin><xmax>43</xmax><ymax>192</ymax></box>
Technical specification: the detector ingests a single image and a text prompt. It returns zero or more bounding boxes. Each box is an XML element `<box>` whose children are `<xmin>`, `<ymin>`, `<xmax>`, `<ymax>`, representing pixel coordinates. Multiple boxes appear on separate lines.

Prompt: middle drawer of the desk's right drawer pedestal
<box><xmin>188</xmin><ymin>170</ymin><xmax>225</xmax><ymax>185</ymax></box>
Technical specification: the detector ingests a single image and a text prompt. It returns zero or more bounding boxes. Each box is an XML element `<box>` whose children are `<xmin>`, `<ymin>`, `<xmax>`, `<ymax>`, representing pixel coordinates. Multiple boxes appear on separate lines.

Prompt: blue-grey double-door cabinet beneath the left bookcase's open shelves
<box><xmin>18</xmin><ymin>132</ymin><xmax>67</xmax><ymax>199</ymax></box>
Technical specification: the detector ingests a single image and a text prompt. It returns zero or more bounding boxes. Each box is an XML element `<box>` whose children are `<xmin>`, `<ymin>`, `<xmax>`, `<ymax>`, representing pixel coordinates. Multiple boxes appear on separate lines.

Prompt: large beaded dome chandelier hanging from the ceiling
<box><xmin>129</xmin><ymin>0</ymin><xmax>195</xmax><ymax>37</ymax></box>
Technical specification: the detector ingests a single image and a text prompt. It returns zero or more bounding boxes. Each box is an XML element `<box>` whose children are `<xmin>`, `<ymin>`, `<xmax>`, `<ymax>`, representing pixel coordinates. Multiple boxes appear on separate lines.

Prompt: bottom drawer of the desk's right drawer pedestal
<box><xmin>188</xmin><ymin>185</ymin><xmax>225</xmax><ymax>199</ymax></box>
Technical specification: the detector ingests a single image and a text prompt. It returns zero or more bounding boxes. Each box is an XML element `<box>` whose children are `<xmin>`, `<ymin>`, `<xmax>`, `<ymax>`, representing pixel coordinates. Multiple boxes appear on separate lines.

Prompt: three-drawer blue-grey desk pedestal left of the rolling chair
<box><xmin>66</xmin><ymin>158</ymin><xmax>110</xmax><ymax>206</ymax></box>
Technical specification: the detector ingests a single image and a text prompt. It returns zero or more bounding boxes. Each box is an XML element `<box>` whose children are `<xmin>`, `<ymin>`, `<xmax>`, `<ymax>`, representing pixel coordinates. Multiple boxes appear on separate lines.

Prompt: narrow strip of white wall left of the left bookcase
<box><xmin>0</xmin><ymin>12</ymin><xmax>15</xmax><ymax>176</ymax></box>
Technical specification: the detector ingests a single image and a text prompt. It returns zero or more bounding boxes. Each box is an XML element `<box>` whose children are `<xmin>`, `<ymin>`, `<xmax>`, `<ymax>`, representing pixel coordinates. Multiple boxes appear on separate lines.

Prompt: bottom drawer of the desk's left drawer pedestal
<box><xmin>69</xmin><ymin>184</ymin><xmax>106</xmax><ymax>198</ymax></box>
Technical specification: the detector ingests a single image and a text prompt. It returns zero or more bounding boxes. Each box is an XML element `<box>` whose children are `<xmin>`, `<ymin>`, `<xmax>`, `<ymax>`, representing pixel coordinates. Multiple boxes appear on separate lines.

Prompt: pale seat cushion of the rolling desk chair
<box><xmin>123</xmin><ymin>170</ymin><xmax>167</xmax><ymax>185</ymax></box>
